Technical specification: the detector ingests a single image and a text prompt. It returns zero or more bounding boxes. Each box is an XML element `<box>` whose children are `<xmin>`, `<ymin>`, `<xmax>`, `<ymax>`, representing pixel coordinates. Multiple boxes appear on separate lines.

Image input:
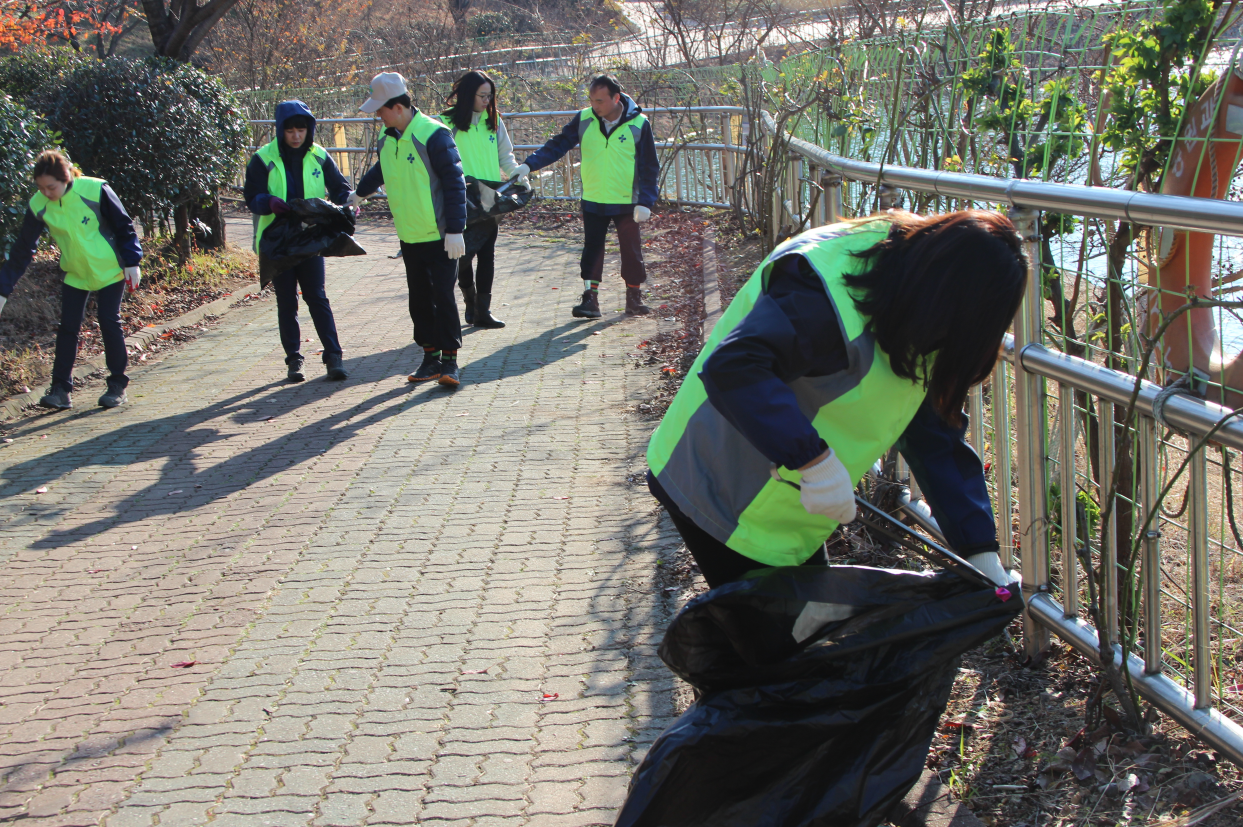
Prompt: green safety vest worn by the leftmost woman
<box><xmin>30</xmin><ymin>178</ymin><xmax>123</xmax><ymax>291</ymax></box>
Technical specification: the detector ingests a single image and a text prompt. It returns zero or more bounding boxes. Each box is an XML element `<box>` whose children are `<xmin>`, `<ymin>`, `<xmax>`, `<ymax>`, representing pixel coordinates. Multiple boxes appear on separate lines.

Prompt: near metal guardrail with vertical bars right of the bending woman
<box><xmin>763</xmin><ymin>113</ymin><xmax>1243</xmax><ymax>765</ymax></box>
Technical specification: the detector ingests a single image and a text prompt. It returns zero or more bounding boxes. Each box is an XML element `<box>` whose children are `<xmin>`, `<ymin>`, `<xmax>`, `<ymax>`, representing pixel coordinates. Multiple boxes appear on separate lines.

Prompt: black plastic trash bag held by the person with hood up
<box><xmin>259</xmin><ymin>198</ymin><xmax>367</xmax><ymax>287</ymax></box>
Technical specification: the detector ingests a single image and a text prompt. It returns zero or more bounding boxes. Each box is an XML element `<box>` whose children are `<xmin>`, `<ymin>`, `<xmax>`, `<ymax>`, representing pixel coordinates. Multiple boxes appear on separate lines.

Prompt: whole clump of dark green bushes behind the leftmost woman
<box><xmin>0</xmin><ymin>50</ymin><xmax>249</xmax><ymax>254</ymax></box>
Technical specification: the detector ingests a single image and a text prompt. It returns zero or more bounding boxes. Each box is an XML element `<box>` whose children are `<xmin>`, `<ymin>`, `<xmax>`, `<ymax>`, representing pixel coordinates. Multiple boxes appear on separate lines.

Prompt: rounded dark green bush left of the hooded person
<box><xmin>48</xmin><ymin>57</ymin><xmax>247</xmax><ymax>228</ymax></box>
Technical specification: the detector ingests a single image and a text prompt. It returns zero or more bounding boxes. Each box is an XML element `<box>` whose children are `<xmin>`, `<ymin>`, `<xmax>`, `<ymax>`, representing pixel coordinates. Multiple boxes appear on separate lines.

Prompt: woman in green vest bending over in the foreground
<box><xmin>648</xmin><ymin>210</ymin><xmax>1027</xmax><ymax>587</ymax></box>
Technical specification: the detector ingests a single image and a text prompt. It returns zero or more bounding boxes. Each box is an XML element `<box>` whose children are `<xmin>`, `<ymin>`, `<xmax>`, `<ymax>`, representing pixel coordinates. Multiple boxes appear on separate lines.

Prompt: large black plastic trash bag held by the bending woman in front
<box><xmin>617</xmin><ymin>566</ymin><xmax>1023</xmax><ymax>827</ymax></box>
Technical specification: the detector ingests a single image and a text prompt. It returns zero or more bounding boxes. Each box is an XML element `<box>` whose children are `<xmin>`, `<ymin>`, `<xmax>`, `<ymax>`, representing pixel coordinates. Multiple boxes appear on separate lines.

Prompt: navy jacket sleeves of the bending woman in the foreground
<box><xmin>700</xmin><ymin>255</ymin><xmax>998</xmax><ymax>552</ymax></box>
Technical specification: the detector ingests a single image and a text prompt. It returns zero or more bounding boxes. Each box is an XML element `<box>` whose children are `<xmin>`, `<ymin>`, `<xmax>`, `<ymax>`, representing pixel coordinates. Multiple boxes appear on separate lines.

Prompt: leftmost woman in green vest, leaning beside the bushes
<box><xmin>0</xmin><ymin>149</ymin><xmax>143</xmax><ymax>408</ymax></box>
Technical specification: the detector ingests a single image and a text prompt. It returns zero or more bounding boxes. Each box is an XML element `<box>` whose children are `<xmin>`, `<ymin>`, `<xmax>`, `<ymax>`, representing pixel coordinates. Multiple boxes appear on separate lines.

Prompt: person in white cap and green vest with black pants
<box><xmin>351</xmin><ymin>72</ymin><xmax>466</xmax><ymax>388</ymax></box>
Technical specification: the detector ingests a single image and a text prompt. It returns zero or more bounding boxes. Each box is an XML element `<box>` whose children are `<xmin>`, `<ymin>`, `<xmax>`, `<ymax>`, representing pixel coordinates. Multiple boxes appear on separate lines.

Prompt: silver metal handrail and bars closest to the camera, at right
<box><xmin>761</xmin><ymin>112</ymin><xmax>1243</xmax><ymax>766</ymax></box>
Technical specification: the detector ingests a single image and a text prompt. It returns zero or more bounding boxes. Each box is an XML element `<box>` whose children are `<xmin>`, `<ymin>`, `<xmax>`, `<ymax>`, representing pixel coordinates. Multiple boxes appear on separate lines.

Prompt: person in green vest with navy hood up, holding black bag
<box><xmin>242</xmin><ymin>101</ymin><xmax>352</xmax><ymax>382</ymax></box>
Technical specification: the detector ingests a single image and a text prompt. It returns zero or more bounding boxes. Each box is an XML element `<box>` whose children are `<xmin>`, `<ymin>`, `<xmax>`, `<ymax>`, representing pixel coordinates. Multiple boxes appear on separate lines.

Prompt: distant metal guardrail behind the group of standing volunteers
<box><xmin>237</xmin><ymin>106</ymin><xmax>750</xmax><ymax>208</ymax></box>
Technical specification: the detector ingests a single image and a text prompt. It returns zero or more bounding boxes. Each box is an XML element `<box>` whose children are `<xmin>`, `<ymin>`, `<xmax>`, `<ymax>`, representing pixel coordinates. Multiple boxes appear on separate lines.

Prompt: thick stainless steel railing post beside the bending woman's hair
<box><xmin>1009</xmin><ymin>208</ymin><xmax>1049</xmax><ymax>657</ymax></box>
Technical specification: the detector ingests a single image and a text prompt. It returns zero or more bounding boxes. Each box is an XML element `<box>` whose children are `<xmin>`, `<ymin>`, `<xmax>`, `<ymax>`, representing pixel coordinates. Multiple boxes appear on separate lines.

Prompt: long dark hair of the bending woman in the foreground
<box><xmin>845</xmin><ymin>210</ymin><xmax>1027</xmax><ymax>425</ymax></box>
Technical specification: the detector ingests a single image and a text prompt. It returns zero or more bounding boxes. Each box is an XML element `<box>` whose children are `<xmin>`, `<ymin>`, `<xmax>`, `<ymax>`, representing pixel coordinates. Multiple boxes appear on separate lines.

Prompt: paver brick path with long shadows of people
<box><xmin>0</xmin><ymin>226</ymin><xmax>675</xmax><ymax>827</ymax></box>
